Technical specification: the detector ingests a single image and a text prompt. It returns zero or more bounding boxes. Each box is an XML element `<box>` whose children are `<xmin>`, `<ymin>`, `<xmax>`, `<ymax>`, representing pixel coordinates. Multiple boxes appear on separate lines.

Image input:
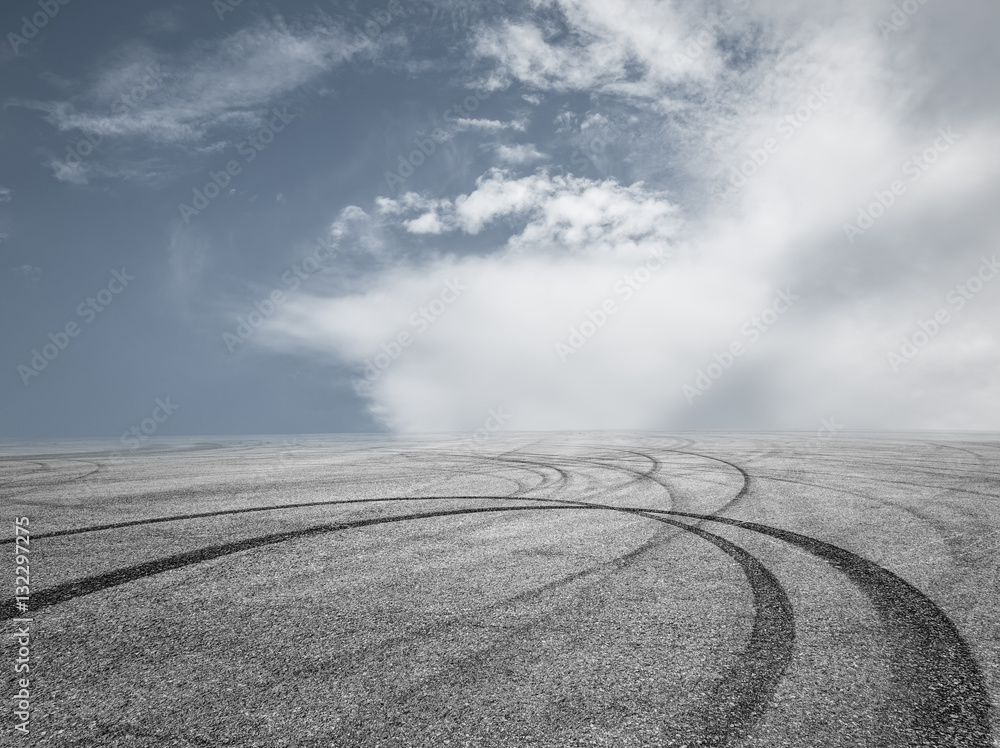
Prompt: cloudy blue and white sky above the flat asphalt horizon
<box><xmin>0</xmin><ymin>0</ymin><xmax>1000</xmax><ymax>438</ymax></box>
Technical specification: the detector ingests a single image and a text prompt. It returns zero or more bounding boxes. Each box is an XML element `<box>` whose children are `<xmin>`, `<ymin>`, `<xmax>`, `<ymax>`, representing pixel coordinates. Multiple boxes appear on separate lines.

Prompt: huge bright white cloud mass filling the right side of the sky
<box><xmin>260</xmin><ymin>0</ymin><xmax>1000</xmax><ymax>431</ymax></box>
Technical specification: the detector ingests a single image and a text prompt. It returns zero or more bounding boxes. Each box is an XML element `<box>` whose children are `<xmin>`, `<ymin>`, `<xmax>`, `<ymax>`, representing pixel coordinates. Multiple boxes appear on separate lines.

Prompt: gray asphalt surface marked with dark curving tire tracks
<box><xmin>0</xmin><ymin>433</ymin><xmax>1000</xmax><ymax>748</ymax></box>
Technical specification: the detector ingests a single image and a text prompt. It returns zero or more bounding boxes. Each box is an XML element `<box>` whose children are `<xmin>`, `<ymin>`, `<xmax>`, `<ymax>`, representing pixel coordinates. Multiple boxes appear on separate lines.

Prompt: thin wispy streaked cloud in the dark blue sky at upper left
<box><xmin>13</xmin><ymin>17</ymin><xmax>371</xmax><ymax>183</ymax></box>
